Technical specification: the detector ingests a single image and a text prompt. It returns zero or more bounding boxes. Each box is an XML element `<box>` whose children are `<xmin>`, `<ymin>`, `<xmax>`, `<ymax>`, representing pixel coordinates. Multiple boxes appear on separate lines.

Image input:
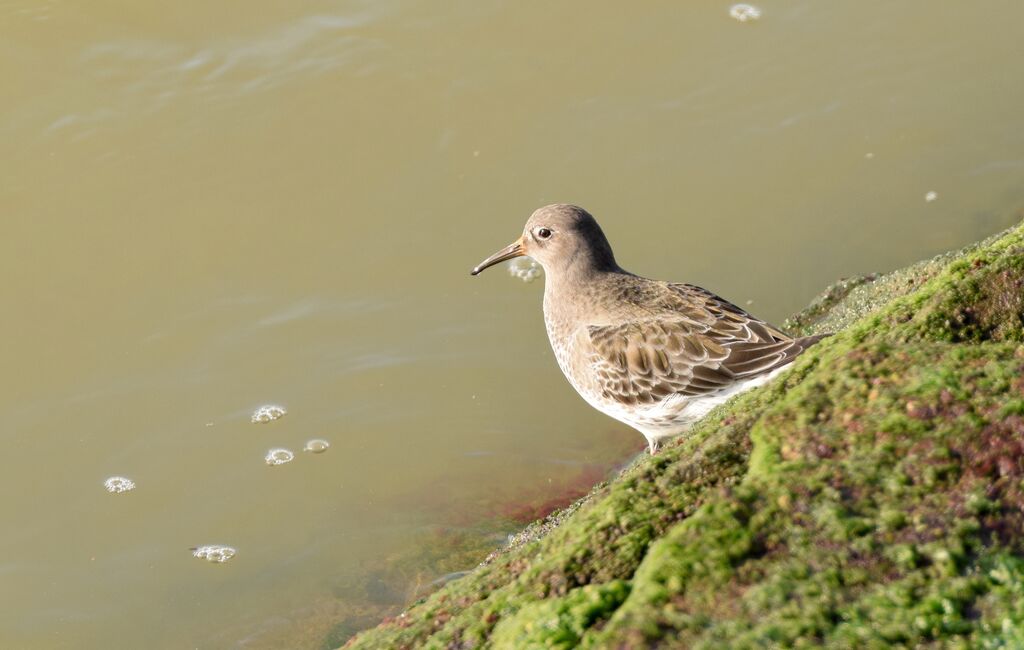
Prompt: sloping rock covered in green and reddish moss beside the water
<box><xmin>346</xmin><ymin>225</ymin><xmax>1024</xmax><ymax>648</ymax></box>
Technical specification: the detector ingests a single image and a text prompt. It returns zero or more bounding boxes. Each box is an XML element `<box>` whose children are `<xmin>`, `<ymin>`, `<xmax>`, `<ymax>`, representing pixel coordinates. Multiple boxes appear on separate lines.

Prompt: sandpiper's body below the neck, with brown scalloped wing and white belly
<box><xmin>545</xmin><ymin>271</ymin><xmax>821</xmax><ymax>448</ymax></box>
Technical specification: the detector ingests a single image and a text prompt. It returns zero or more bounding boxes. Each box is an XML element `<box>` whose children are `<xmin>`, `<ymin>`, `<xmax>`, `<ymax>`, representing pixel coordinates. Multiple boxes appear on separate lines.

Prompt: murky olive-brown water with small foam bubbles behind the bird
<box><xmin>0</xmin><ymin>0</ymin><xmax>1024</xmax><ymax>648</ymax></box>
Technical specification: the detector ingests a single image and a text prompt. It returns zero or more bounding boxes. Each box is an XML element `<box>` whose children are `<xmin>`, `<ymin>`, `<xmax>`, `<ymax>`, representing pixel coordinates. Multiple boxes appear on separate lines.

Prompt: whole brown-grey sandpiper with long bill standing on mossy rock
<box><xmin>470</xmin><ymin>204</ymin><xmax>828</xmax><ymax>456</ymax></box>
